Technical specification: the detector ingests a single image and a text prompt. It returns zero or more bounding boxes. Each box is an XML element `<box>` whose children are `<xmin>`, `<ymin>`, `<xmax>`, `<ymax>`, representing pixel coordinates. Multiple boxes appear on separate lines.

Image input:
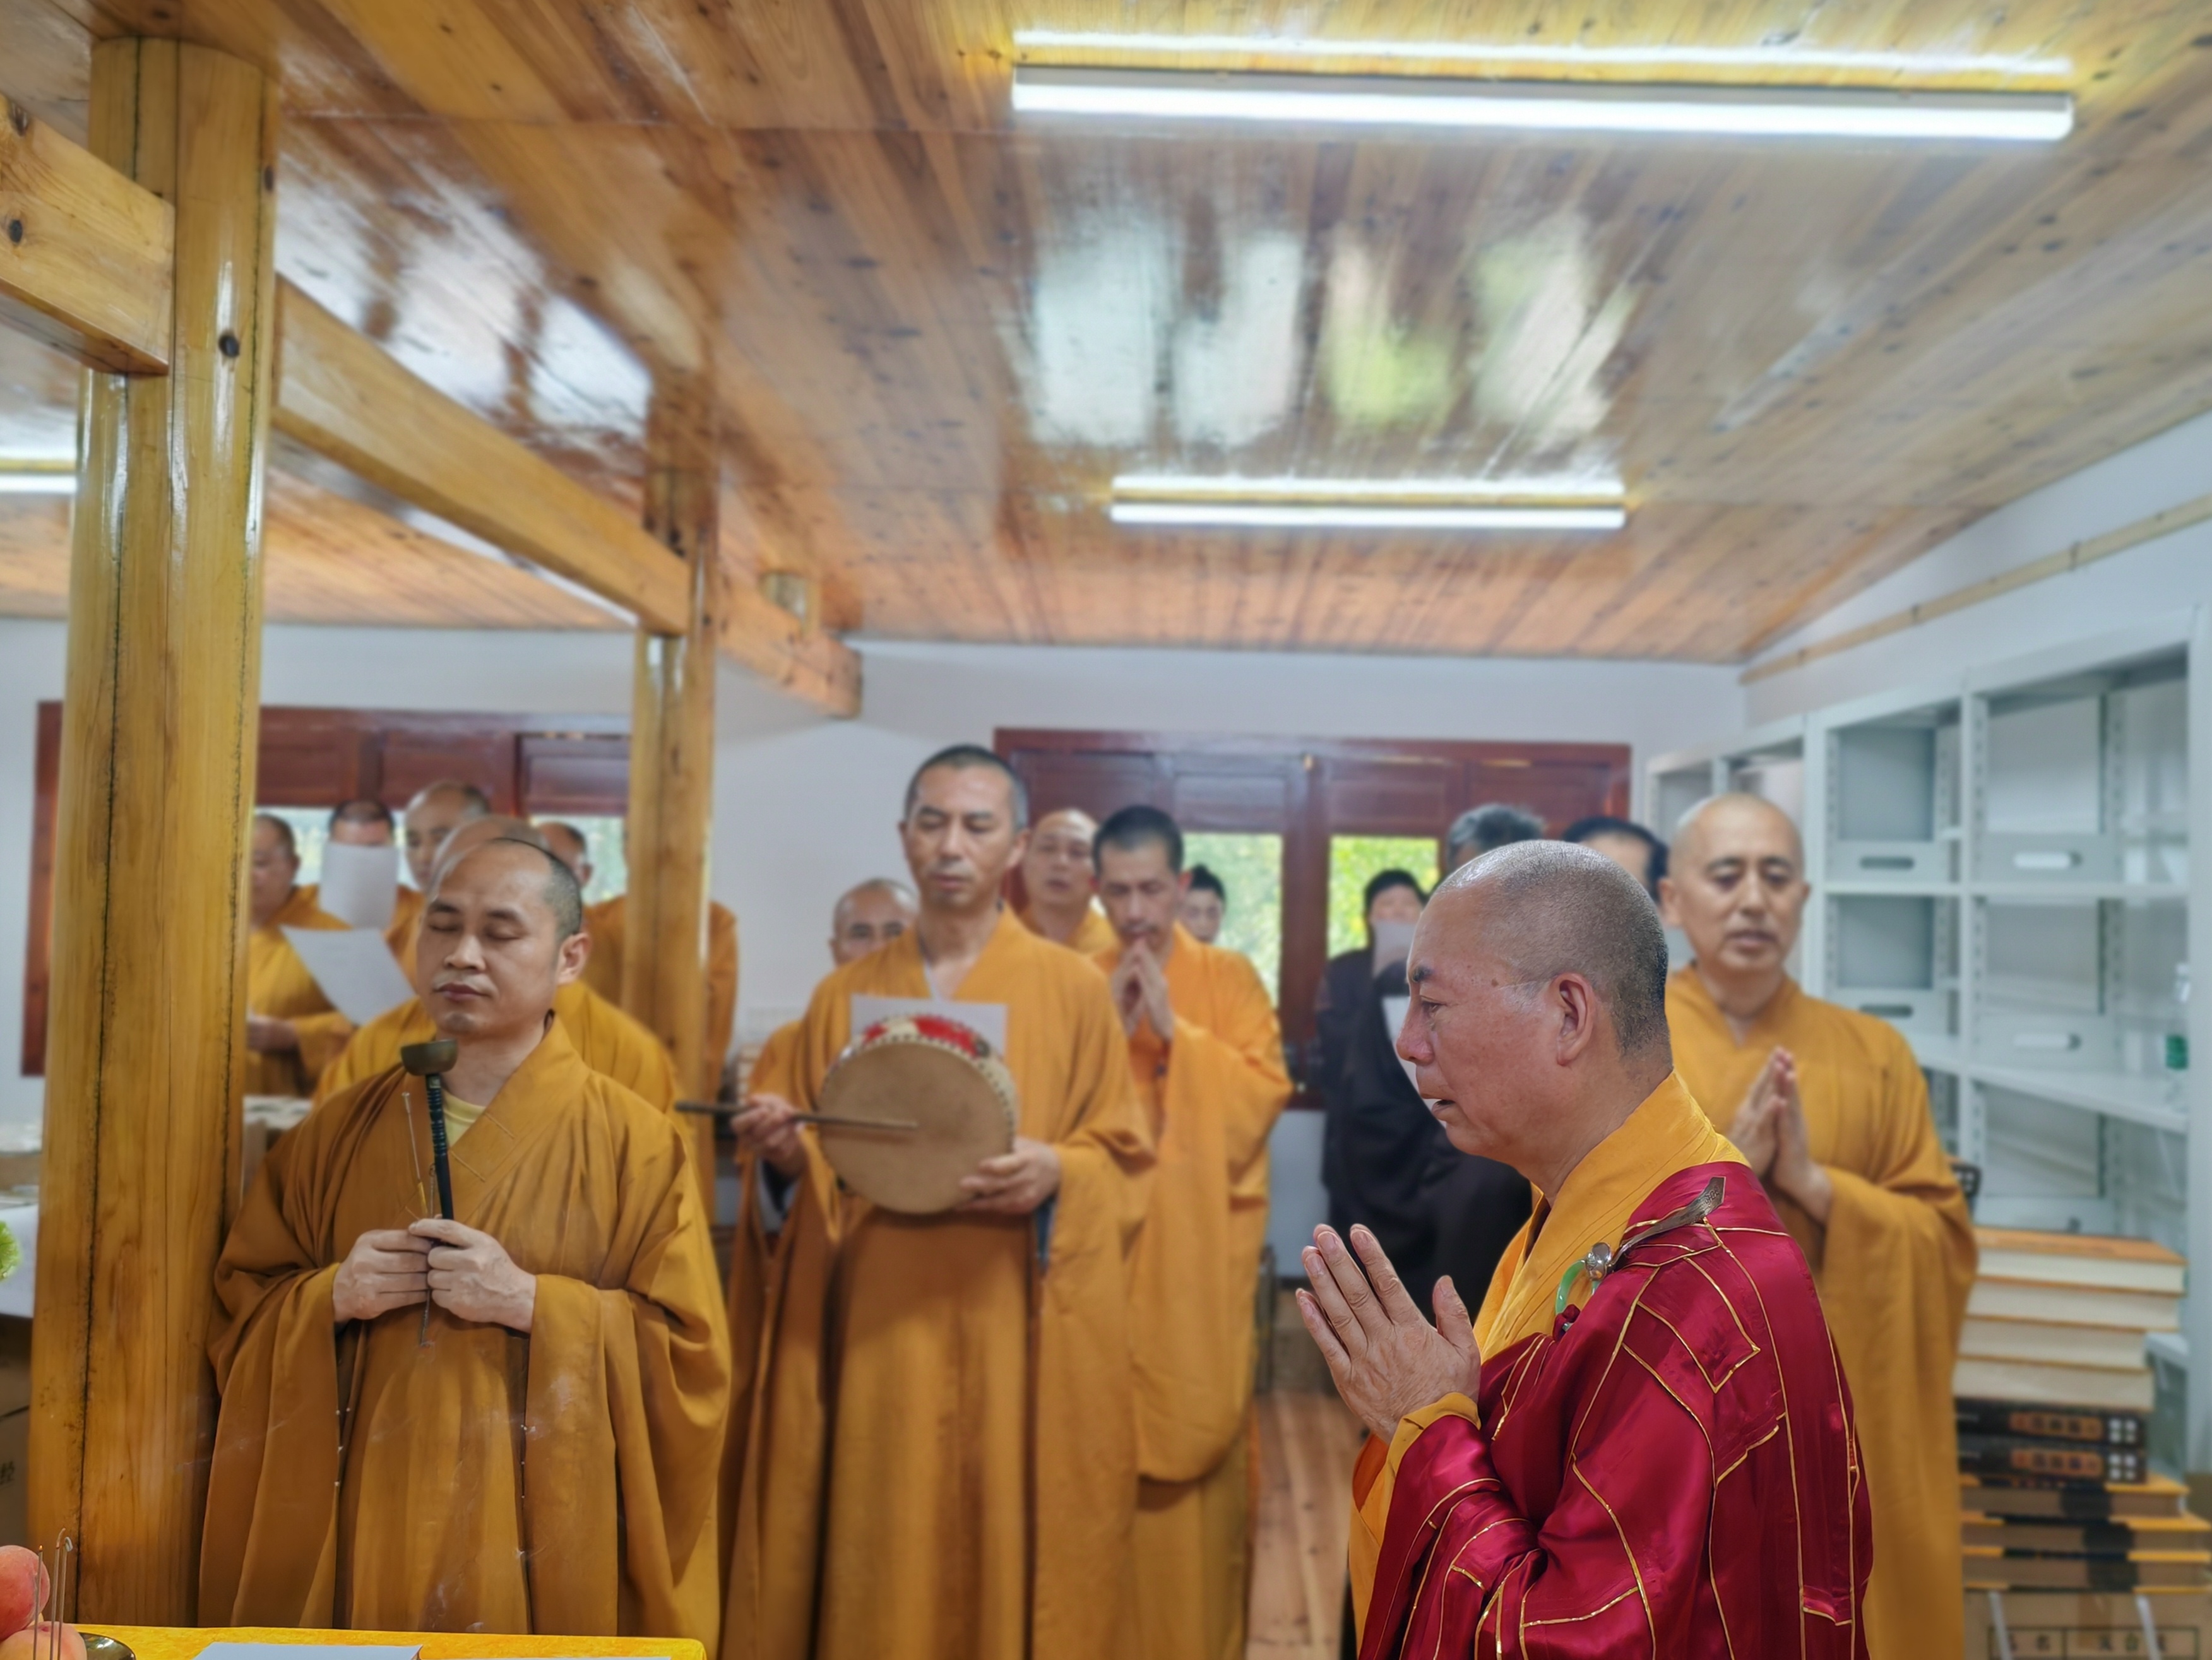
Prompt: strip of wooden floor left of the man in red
<box><xmin>1246</xmin><ymin>1298</ymin><xmax>1360</xmax><ymax>1660</ymax></box>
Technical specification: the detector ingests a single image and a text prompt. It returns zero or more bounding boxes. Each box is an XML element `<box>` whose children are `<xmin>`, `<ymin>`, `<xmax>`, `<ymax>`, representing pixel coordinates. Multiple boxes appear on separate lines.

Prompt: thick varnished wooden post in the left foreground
<box><xmin>29</xmin><ymin>40</ymin><xmax>276</xmax><ymax>1625</ymax></box>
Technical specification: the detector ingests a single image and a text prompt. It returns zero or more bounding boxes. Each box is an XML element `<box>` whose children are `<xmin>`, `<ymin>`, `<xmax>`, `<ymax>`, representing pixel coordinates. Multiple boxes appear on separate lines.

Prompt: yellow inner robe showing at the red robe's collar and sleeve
<box><xmin>1352</xmin><ymin>1070</ymin><xmax>1752</xmax><ymax>1653</ymax></box>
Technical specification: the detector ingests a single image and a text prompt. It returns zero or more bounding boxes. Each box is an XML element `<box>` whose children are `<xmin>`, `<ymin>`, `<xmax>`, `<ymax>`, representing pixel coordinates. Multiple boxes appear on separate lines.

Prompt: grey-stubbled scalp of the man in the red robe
<box><xmin>1413</xmin><ymin>842</ymin><xmax>1672</xmax><ymax>1058</ymax></box>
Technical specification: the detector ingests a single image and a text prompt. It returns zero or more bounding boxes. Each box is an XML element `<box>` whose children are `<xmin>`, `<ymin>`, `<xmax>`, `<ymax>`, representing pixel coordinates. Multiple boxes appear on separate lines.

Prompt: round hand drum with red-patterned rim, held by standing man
<box><xmin>814</xmin><ymin>1014</ymin><xmax>1018</xmax><ymax>1216</ymax></box>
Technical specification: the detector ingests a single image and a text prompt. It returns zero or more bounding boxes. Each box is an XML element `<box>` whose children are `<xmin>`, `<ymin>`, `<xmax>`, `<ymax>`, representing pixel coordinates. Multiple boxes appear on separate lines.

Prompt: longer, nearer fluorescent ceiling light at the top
<box><xmin>1013</xmin><ymin>64</ymin><xmax>2072</xmax><ymax>141</ymax></box>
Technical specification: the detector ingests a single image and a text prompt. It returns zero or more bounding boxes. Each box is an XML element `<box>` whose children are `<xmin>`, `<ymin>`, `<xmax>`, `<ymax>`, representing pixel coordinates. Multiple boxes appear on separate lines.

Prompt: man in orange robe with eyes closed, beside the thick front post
<box><xmin>199</xmin><ymin>840</ymin><xmax>730</xmax><ymax>1653</ymax></box>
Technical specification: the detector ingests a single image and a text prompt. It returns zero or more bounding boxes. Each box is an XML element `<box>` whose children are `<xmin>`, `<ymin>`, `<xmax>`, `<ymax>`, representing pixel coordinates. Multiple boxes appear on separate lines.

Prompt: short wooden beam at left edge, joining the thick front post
<box><xmin>0</xmin><ymin>100</ymin><xmax>177</xmax><ymax>374</ymax></box>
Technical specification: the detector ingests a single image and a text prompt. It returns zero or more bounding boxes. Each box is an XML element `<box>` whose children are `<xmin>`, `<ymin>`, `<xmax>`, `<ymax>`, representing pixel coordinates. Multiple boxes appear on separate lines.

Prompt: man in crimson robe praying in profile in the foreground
<box><xmin>1299</xmin><ymin>842</ymin><xmax>1871</xmax><ymax>1660</ymax></box>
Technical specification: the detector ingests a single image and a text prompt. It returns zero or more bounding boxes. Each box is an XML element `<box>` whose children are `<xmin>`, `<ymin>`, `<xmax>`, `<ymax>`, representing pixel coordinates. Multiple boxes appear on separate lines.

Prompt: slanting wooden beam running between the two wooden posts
<box><xmin>276</xmin><ymin>283</ymin><xmax>690</xmax><ymax>634</ymax></box>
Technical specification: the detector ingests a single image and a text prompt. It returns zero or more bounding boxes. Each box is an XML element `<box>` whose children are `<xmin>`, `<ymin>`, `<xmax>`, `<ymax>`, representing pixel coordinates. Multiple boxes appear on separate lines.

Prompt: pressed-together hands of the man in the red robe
<box><xmin>1299</xmin><ymin>1227</ymin><xmax>1482</xmax><ymax>1441</ymax></box>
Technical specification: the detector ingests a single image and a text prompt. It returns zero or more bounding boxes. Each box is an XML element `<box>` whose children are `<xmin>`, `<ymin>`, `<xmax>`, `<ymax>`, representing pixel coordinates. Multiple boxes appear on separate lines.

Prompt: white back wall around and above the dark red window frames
<box><xmin>0</xmin><ymin>619</ymin><xmax>1741</xmax><ymax>1167</ymax></box>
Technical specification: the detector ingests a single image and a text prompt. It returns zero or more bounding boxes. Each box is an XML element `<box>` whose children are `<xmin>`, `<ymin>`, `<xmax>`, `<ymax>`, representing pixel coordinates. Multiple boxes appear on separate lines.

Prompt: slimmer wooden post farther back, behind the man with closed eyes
<box><xmin>622</xmin><ymin>378</ymin><xmax>723</xmax><ymax>1218</ymax></box>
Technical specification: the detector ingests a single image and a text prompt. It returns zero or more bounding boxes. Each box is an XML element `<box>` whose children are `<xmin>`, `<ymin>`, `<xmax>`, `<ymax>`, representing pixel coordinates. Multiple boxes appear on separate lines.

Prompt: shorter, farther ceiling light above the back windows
<box><xmin>1109</xmin><ymin>475</ymin><xmax>1628</xmax><ymax>530</ymax></box>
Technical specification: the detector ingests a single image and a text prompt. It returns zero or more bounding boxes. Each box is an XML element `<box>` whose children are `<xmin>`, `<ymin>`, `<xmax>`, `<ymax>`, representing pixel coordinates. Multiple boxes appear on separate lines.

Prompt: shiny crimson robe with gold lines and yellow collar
<box><xmin>1360</xmin><ymin>1076</ymin><xmax>1874</xmax><ymax>1660</ymax></box>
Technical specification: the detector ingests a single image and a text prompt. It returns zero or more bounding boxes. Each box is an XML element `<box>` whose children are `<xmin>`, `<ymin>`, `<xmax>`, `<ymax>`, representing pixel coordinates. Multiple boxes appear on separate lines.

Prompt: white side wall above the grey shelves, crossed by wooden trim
<box><xmin>1743</xmin><ymin>404</ymin><xmax>2212</xmax><ymax>720</ymax></box>
